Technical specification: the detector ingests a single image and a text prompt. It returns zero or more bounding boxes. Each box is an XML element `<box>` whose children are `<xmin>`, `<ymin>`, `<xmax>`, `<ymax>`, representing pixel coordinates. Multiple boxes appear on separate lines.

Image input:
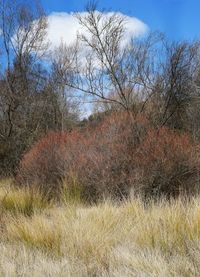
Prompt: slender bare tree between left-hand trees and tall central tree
<box><xmin>51</xmin><ymin>42</ymin><xmax>81</xmax><ymax>131</ymax></box>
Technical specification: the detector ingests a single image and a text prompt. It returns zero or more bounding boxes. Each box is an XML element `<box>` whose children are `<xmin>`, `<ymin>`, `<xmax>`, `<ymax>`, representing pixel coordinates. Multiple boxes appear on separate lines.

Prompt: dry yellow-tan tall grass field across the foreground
<box><xmin>0</xmin><ymin>180</ymin><xmax>200</xmax><ymax>277</ymax></box>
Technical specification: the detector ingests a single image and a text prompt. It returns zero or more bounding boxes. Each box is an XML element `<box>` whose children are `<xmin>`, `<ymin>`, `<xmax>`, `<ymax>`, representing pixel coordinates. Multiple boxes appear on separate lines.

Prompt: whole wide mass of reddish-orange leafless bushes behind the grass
<box><xmin>17</xmin><ymin>112</ymin><xmax>199</xmax><ymax>200</ymax></box>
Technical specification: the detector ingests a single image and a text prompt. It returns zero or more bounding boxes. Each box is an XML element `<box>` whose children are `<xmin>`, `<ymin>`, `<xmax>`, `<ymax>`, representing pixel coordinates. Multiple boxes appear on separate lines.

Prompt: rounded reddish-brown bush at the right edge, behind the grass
<box><xmin>134</xmin><ymin>127</ymin><xmax>199</xmax><ymax>196</ymax></box>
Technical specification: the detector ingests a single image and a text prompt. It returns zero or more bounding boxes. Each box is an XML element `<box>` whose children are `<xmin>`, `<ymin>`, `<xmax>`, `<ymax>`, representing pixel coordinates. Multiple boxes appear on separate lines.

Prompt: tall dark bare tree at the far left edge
<box><xmin>0</xmin><ymin>0</ymin><xmax>47</xmax><ymax>172</ymax></box>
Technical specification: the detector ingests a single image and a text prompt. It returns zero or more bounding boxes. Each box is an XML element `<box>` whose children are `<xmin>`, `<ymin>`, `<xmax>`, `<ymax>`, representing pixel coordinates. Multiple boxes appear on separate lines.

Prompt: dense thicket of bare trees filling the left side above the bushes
<box><xmin>0</xmin><ymin>0</ymin><xmax>79</xmax><ymax>175</ymax></box>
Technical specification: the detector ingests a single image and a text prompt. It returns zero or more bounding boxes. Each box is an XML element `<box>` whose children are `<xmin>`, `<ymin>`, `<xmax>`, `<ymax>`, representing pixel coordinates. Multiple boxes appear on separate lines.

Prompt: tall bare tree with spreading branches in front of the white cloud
<box><xmin>60</xmin><ymin>3</ymin><xmax>162</xmax><ymax>111</ymax></box>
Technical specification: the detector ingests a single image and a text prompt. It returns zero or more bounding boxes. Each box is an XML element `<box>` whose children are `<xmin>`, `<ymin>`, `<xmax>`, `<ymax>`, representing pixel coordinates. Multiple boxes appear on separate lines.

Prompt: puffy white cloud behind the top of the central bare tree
<box><xmin>48</xmin><ymin>12</ymin><xmax>148</xmax><ymax>48</ymax></box>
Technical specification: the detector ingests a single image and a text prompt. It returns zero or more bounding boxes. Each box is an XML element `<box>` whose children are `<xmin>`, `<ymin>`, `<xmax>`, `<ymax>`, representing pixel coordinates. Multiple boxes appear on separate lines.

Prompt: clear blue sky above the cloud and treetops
<box><xmin>42</xmin><ymin>0</ymin><xmax>200</xmax><ymax>39</ymax></box>
